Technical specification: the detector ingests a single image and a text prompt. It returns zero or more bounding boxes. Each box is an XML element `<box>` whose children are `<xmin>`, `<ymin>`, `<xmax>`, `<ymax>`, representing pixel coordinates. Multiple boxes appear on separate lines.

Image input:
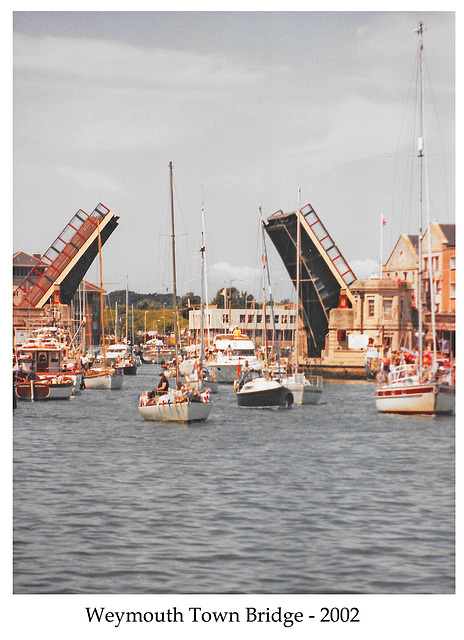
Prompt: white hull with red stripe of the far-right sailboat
<box><xmin>375</xmin><ymin>382</ymin><xmax>455</xmax><ymax>414</ymax></box>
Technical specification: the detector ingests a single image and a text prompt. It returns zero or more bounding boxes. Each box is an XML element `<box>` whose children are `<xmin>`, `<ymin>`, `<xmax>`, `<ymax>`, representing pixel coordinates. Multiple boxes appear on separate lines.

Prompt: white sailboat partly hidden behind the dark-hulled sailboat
<box><xmin>282</xmin><ymin>189</ymin><xmax>322</xmax><ymax>404</ymax></box>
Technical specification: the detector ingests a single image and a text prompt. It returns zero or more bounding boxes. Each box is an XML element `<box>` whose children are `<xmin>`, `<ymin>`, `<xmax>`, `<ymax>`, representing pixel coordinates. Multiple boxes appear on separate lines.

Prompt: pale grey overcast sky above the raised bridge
<box><xmin>13</xmin><ymin>11</ymin><xmax>455</xmax><ymax>299</ymax></box>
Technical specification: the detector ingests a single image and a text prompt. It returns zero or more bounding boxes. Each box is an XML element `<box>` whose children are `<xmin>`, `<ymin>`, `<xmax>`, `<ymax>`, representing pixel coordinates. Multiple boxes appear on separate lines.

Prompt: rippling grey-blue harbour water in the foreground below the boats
<box><xmin>14</xmin><ymin>365</ymin><xmax>455</xmax><ymax>594</ymax></box>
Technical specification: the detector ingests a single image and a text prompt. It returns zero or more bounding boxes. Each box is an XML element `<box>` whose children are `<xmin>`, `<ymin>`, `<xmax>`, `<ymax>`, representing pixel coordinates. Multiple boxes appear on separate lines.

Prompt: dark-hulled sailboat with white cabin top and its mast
<box><xmin>235</xmin><ymin>208</ymin><xmax>293</xmax><ymax>409</ymax></box>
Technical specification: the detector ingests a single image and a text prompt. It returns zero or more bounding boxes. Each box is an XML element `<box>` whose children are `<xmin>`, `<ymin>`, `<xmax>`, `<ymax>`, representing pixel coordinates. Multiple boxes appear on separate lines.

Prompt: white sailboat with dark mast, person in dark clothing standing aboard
<box><xmin>139</xmin><ymin>162</ymin><xmax>213</xmax><ymax>422</ymax></box>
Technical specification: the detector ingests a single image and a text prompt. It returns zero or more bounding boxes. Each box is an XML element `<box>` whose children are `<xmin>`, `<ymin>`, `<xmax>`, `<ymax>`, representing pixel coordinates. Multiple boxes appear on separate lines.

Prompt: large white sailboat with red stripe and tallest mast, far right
<box><xmin>375</xmin><ymin>22</ymin><xmax>455</xmax><ymax>414</ymax></box>
